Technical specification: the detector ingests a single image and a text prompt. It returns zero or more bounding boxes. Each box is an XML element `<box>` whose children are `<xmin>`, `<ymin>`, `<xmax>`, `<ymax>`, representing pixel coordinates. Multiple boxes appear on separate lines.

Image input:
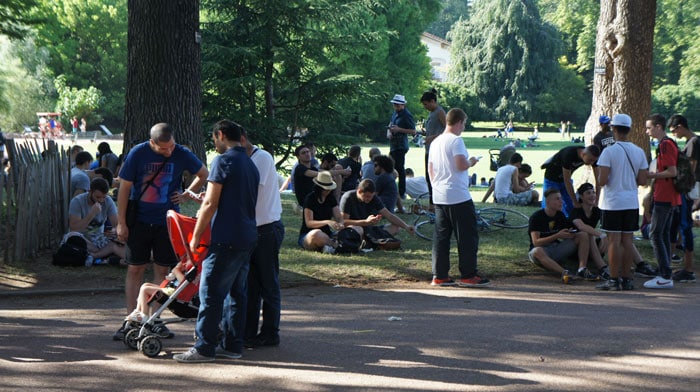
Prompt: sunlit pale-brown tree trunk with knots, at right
<box><xmin>586</xmin><ymin>0</ymin><xmax>656</xmax><ymax>154</ymax></box>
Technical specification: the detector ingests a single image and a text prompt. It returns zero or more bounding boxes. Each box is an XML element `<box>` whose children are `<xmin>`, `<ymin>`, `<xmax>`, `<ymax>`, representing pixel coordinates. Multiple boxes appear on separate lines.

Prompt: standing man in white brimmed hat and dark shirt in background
<box><xmin>387</xmin><ymin>94</ymin><xmax>416</xmax><ymax>208</ymax></box>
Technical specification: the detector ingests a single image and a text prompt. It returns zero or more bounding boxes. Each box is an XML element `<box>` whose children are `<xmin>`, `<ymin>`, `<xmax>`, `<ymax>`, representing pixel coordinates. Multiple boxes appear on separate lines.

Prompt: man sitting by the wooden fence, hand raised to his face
<box><xmin>68</xmin><ymin>177</ymin><xmax>126</xmax><ymax>259</ymax></box>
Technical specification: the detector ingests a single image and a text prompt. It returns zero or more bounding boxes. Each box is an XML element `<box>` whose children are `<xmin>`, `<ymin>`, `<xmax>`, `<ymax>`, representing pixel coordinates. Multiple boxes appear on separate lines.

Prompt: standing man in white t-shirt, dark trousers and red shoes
<box><xmin>428</xmin><ymin>109</ymin><xmax>489</xmax><ymax>287</ymax></box>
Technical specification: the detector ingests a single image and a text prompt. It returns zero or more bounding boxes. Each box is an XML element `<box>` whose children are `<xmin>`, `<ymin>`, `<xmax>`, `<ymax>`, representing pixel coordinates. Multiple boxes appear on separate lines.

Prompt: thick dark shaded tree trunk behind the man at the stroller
<box><xmin>124</xmin><ymin>0</ymin><xmax>206</xmax><ymax>162</ymax></box>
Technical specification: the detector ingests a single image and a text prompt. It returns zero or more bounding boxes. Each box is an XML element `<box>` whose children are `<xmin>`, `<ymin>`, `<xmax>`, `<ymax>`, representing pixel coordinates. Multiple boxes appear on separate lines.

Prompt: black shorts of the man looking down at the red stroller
<box><xmin>126</xmin><ymin>222</ymin><xmax>177</xmax><ymax>267</ymax></box>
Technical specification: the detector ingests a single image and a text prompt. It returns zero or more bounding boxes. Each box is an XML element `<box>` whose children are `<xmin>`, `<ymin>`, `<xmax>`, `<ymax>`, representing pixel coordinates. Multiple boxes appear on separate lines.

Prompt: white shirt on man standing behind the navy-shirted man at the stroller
<box><xmin>250</xmin><ymin>147</ymin><xmax>282</xmax><ymax>226</ymax></box>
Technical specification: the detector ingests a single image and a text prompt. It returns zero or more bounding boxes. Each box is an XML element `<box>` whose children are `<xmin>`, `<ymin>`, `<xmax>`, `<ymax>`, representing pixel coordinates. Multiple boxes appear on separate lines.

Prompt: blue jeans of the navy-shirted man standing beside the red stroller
<box><xmin>194</xmin><ymin>244</ymin><xmax>252</xmax><ymax>357</ymax></box>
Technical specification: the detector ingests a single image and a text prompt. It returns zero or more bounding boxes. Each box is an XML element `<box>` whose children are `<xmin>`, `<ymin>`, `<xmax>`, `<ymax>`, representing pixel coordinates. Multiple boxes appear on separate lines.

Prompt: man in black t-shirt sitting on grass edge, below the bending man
<box><xmin>527</xmin><ymin>188</ymin><xmax>598</xmax><ymax>283</ymax></box>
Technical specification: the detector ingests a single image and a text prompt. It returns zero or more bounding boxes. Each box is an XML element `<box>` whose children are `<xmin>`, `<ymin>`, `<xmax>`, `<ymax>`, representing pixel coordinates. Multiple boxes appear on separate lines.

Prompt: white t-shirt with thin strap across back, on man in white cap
<box><xmin>598</xmin><ymin>142</ymin><xmax>649</xmax><ymax>211</ymax></box>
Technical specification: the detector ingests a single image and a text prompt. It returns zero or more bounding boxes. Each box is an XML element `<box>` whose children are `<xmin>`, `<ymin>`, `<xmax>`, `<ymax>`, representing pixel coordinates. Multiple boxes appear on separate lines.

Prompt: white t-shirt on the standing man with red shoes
<box><xmin>428</xmin><ymin>132</ymin><xmax>472</xmax><ymax>205</ymax></box>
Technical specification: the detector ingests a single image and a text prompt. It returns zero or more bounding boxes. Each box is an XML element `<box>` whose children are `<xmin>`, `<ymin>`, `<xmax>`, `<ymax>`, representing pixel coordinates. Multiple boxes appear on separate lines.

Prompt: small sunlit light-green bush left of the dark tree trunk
<box><xmin>56</xmin><ymin>75</ymin><xmax>104</xmax><ymax>123</ymax></box>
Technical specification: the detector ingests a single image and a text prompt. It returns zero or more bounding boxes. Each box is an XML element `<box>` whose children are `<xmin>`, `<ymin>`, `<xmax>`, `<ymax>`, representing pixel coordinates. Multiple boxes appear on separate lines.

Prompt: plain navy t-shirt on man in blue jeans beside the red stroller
<box><xmin>208</xmin><ymin>147</ymin><xmax>260</xmax><ymax>250</ymax></box>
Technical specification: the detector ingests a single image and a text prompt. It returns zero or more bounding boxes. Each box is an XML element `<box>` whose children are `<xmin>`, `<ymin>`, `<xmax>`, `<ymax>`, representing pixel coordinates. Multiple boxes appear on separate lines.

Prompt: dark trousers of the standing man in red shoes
<box><xmin>433</xmin><ymin>200</ymin><xmax>479</xmax><ymax>279</ymax></box>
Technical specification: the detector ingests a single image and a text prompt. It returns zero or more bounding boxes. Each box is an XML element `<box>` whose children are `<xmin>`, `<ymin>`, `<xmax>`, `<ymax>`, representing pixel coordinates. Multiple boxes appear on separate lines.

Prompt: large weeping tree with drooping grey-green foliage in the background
<box><xmin>449</xmin><ymin>0</ymin><xmax>560</xmax><ymax>119</ymax></box>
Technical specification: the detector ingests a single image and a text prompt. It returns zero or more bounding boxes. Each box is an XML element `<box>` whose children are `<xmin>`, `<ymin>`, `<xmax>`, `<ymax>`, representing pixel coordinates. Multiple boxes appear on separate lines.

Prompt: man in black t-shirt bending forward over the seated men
<box><xmin>542</xmin><ymin>145</ymin><xmax>600</xmax><ymax>216</ymax></box>
